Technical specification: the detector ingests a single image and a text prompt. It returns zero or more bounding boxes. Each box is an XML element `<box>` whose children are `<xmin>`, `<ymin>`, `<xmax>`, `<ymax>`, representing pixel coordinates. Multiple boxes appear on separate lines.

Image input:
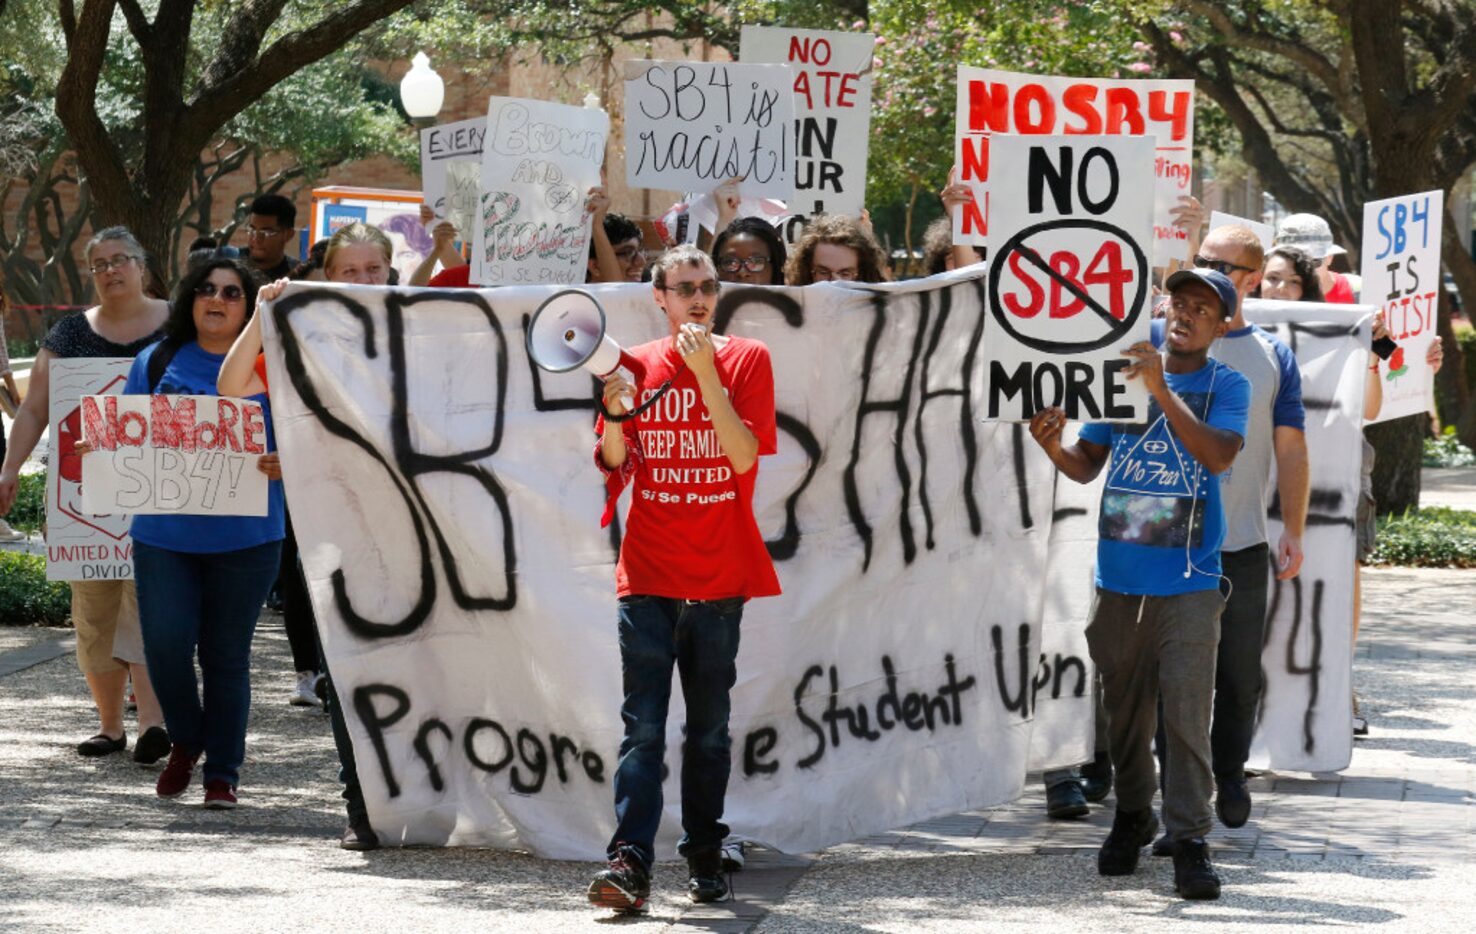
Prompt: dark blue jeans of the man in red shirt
<box><xmin>607</xmin><ymin>596</ymin><xmax>744</xmax><ymax>868</ymax></box>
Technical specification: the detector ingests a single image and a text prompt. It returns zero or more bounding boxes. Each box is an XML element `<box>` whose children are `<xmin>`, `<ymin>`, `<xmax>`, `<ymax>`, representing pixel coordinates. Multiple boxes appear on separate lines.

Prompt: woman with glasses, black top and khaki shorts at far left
<box><xmin>0</xmin><ymin>227</ymin><xmax>170</xmax><ymax>764</ymax></box>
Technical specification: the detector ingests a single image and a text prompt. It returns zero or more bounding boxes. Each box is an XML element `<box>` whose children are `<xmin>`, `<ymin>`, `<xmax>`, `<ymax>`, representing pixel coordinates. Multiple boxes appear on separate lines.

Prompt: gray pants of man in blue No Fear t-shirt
<box><xmin>1086</xmin><ymin>589</ymin><xmax>1225</xmax><ymax>841</ymax></box>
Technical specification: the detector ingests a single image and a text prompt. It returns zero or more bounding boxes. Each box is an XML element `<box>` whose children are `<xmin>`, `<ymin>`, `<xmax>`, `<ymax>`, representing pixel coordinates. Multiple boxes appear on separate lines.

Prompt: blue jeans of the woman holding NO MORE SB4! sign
<box><xmin>133</xmin><ymin>542</ymin><xmax>282</xmax><ymax>785</ymax></box>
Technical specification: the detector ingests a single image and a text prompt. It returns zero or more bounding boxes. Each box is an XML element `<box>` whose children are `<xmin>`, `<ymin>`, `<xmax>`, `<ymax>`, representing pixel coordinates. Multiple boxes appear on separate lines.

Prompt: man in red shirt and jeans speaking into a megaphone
<box><xmin>589</xmin><ymin>246</ymin><xmax>779</xmax><ymax>912</ymax></box>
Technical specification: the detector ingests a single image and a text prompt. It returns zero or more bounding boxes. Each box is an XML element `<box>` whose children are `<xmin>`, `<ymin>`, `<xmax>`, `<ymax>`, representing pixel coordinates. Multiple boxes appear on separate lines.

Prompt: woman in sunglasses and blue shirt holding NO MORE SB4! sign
<box><xmin>124</xmin><ymin>257</ymin><xmax>283</xmax><ymax>809</ymax></box>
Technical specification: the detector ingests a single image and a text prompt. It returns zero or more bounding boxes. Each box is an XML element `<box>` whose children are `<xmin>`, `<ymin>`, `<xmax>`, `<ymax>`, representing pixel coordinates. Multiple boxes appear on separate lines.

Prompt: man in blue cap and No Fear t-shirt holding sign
<box><xmin>1030</xmin><ymin>269</ymin><xmax>1250</xmax><ymax>899</ymax></box>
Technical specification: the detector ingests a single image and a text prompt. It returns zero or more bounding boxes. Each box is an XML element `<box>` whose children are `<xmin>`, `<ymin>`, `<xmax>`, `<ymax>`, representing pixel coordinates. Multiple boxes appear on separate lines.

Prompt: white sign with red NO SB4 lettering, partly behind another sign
<box><xmin>953</xmin><ymin>65</ymin><xmax>1194</xmax><ymax>266</ymax></box>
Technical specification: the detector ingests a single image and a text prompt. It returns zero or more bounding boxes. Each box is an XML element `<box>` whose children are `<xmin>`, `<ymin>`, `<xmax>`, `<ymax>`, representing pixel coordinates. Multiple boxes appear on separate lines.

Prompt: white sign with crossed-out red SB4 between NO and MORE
<box><xmin>984</xmin><ymin>136</ymin><xmax>1153</xmax><ymax>422</ymax></box>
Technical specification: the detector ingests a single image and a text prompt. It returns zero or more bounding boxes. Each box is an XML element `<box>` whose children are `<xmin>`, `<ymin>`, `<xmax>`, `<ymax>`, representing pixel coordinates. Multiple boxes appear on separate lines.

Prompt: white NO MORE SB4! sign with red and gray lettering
<box><xmin>81</xmin><ymin>395</ymin><xmax>267</xmax><ymax>515</ymax></box>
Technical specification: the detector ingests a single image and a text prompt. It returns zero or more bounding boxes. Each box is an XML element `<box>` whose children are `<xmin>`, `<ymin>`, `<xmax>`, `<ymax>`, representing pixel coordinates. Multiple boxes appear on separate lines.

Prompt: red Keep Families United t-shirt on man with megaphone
<box><xmin>595</xmin><ymin>338</ymin><xmax>779</xmax><ymax>601</ymax></box>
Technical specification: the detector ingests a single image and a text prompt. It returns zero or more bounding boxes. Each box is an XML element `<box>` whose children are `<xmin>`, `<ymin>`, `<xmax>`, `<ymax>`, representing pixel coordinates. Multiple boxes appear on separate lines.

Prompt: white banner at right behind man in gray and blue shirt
<box><xmin>1244</xmin><ymin>300</ymin><xmax>1374</xmax><ymax>772</ymax></box>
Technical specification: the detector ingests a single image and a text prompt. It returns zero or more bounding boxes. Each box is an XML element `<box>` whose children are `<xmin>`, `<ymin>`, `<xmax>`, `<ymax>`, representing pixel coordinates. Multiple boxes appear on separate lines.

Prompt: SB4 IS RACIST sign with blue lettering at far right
<box><xmin>1361</xmin><ymin>192</ymin><xmax>1445</xmax><ymax>422</ymax></box>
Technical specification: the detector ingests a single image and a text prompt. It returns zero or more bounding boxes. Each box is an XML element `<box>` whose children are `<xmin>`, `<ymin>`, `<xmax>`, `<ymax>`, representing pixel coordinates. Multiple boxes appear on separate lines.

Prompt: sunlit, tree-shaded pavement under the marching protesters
<box><xmin>0</xmin><ymin>560</ymin><xmax>1476</xmax><ymax>934</ymax></box>
